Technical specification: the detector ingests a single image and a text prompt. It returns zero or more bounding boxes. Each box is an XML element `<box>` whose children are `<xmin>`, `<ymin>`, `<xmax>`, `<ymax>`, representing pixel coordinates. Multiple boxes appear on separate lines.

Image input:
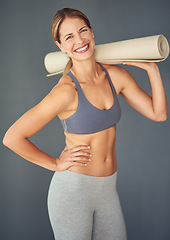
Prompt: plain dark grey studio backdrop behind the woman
<box><xmin>0</xmin><ymin>0</ymin><xmax>170</xmax><ymax>240</ymax></box>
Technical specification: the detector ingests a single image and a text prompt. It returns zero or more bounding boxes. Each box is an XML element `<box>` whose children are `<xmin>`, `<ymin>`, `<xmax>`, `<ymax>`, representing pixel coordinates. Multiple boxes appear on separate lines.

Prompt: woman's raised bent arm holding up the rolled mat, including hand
<box><xmin>109</xmin><ymin>61</ymin><xmax>167</xmax><ymax>121</ymax></box>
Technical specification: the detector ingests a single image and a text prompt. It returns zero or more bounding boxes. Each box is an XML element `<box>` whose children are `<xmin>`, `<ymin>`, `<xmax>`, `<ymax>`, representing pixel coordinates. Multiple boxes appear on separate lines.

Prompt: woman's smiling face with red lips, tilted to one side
<box><xmin>56</xmin><ymin>17</ymin><xmax>95</xmax><ymax>61</ymax></box>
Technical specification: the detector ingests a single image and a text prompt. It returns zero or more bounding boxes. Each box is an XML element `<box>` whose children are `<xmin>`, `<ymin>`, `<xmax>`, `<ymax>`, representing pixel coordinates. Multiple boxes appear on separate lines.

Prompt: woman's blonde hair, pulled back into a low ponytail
<box><xmin>51</xmin><ymin>8</ymin><xmax>92</xmax><ymax>74</ymax></box>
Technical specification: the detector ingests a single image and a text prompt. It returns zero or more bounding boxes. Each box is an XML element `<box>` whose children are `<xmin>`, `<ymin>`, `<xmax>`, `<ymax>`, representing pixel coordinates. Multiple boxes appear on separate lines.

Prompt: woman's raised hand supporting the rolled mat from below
<box><xmin>123</xmin><ymin>61</ymin><xmax>159</xmax><ymax>72</ymax></box>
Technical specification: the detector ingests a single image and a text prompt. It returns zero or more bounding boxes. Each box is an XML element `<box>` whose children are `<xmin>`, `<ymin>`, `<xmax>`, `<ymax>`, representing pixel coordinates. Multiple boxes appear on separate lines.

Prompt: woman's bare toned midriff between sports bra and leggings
<box><xmin>64</xmin><ymin>127</ymin><xmax>117</xmax><ymax>177</ymax></box>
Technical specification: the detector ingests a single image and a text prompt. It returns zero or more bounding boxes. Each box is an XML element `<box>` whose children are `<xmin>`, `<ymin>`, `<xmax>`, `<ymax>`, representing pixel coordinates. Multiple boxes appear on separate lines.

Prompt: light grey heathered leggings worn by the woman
<box><xmin>47</xmin><ymin>170</ymin><xmax>127</xmax><ymax>240</ymax></box>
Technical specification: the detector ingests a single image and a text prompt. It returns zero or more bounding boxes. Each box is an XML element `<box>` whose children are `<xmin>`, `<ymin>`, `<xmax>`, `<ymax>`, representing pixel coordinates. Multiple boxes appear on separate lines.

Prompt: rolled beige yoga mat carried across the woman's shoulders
<box><xmin>44</xmin><ymin>34</ymin><xmax>169</xmax><ymax>76</ymax></box>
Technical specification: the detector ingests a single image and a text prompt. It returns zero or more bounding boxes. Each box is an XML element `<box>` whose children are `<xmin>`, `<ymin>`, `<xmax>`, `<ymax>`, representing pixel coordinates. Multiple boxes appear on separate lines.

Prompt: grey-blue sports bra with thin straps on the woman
<box><xmin>61</xmin><ymin>63</ymin><xmax>121</xmax><ymax>134</ymax></box>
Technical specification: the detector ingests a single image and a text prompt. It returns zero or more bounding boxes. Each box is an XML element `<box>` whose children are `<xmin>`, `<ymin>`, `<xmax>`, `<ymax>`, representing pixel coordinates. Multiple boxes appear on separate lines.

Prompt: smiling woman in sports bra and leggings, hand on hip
<box><xmin>4</xmin><ymin>8</ymin><xmax>167</xmax><ymax>240</ymax></box>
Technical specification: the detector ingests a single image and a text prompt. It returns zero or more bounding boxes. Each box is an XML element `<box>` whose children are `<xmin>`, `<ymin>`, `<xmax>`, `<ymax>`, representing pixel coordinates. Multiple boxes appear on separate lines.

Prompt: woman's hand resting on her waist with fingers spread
<box><xmin>56</xmin><ymin>145</ymin><xmax>92</xmax><ymax>171</ymax></box>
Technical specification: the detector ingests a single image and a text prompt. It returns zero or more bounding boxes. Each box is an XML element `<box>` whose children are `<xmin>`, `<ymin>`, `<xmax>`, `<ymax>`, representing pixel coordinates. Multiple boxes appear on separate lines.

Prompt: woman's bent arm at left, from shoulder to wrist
<box><xmin>3</xmin><ymin>80</ymin><xmax>75</xmax><ymax>171</ymax></box>
